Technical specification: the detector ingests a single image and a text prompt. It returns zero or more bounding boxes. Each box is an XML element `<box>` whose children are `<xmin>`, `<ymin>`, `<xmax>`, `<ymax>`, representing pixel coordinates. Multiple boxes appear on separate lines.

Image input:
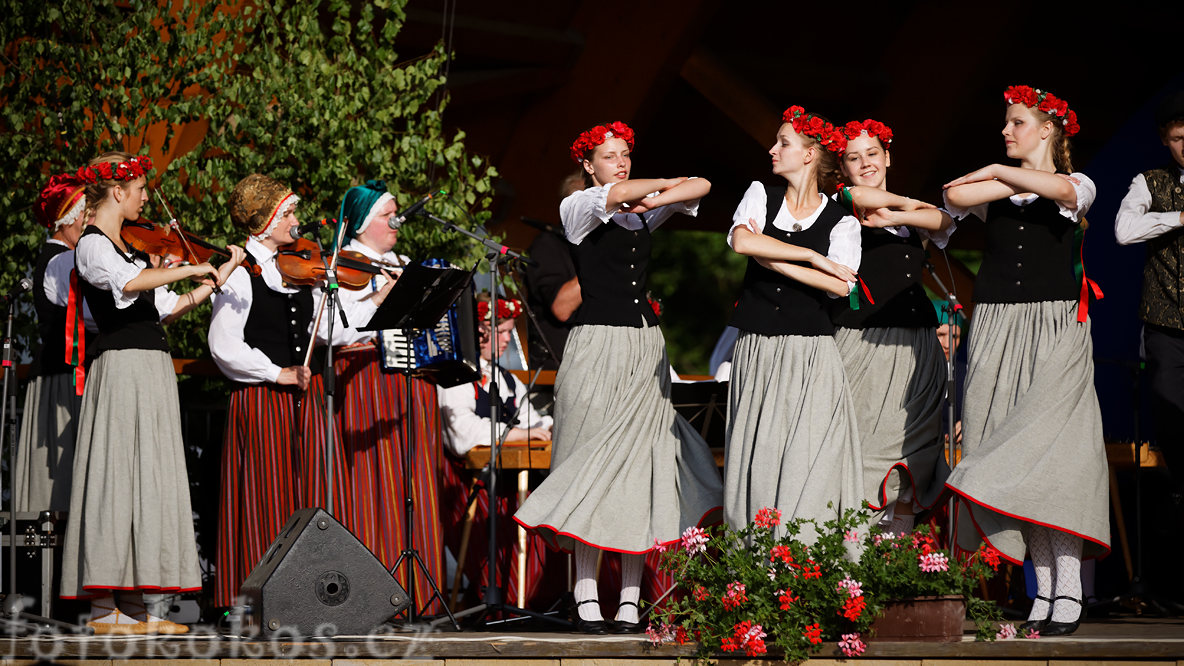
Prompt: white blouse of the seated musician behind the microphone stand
<box><xmin>436</xmin><ymin>359</ymin><xmax>553</xmax><ymax>456</ymax></box>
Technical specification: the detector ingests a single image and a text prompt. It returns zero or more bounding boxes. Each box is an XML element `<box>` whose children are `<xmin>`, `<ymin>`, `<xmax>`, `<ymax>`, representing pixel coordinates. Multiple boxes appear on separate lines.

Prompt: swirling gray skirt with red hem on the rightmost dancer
<box><xmin>946</xmin><ymin>301</ymin><xmax>1109</xmax><ymax>562</ymax></box>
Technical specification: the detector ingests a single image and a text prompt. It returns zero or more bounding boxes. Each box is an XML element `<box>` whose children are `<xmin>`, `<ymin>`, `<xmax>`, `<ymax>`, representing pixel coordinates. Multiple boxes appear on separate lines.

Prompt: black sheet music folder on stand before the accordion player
<box><xmin>358</xmin><ymin>264</ymin><xmax>477</xmax><ymax>331</ymax></box>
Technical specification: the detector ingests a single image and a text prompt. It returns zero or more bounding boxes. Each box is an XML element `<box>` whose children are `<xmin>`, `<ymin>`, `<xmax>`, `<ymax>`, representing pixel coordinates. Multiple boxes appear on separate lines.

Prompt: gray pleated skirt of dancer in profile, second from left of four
<box><xmin>723</xmin><ymin>332</ymin><xmax>863</xmax><ymax>539</ymax></box>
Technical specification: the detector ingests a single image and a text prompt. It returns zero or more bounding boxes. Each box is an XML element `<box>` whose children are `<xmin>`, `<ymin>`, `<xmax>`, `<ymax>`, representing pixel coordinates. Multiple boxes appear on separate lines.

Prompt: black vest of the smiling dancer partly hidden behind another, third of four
<box><xmin>831</xmin><ymin>226</ymin><xmax>938</xmax><ymax>328</ymax></box>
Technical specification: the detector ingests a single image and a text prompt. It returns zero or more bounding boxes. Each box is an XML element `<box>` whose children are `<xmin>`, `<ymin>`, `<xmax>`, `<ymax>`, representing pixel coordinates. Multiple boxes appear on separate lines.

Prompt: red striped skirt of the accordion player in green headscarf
<box><xmin>331</xmin><ymin>347</ymin><xmax>444</xmax><ymax>614</ymax></box>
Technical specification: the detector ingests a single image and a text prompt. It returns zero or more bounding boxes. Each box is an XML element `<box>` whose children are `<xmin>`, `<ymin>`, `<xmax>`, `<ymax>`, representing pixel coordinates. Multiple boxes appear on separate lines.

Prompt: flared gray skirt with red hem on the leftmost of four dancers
<box><xmin>514</xmin><ymin>326</ymin><xmax>722</xmax><ymax>553</ymax></box>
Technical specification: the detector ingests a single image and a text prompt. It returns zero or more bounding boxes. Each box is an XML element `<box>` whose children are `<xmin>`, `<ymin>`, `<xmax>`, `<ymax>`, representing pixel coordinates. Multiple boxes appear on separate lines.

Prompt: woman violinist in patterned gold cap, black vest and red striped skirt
<box><xmin>208</xmin><ymin>173</ymin><xmax>345</xmax><ymax>606</ymax></box>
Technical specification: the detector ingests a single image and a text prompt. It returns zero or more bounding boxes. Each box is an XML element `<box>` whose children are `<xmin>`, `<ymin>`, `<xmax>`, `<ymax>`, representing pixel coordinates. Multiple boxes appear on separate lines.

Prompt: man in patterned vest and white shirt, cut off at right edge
<box><xmin>1114</xmin><ymin>90</ymin><xmax>1184</xmax><ymax>504</ymax></box>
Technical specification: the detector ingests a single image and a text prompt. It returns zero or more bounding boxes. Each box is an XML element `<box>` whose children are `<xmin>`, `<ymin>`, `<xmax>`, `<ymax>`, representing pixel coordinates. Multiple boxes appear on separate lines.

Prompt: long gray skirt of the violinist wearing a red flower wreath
<box><xmin>62</xmin><ymin>350</ymin><xmax>201</xmax><ymax>597</ymax></box>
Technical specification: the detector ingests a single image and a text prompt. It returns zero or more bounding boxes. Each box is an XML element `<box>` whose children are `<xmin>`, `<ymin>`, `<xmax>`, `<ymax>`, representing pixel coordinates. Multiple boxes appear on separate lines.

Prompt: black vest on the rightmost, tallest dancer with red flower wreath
<box><xmin>974</xmin><ymin>193</ymin><xmax>1081</xmax><ymax>303</ymax></box>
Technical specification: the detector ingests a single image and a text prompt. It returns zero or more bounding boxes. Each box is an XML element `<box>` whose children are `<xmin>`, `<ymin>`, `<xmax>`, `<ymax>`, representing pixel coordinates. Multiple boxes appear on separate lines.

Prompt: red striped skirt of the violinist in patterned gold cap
<box><xmin>214</xmin><ymin>374</ymin><xmax>331</xmax><ymax>606</ymax></box>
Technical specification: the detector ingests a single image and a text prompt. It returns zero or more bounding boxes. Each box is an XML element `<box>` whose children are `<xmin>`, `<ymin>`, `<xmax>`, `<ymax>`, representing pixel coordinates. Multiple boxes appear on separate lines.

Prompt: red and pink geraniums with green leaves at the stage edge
<box><xmin>648</xmin><ymin>500</ymin><xmax>998</xmax><ymax>661</ymax></box>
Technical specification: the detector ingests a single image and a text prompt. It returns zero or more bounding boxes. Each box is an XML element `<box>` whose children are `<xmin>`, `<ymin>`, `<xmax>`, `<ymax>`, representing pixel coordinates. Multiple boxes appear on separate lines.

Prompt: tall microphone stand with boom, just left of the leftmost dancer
<box><xmin>420</xmin><ymin>211</ymin><xmax>572</xmax><ymax>627</ymax></box>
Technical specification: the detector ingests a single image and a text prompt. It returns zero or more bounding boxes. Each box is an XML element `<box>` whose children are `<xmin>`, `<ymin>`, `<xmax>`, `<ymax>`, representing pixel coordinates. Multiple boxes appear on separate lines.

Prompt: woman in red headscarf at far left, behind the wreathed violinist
<box><xmin>14</xmin><ymin>174</ymin><xmax>94</xmax><ymax>511</ymax></box>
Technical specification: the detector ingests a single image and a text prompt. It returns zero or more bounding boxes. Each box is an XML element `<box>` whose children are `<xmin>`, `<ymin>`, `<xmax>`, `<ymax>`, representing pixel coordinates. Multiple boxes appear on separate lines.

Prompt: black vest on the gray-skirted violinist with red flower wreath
<box><xmin>78</xmin><ymin>226</ymin><xmax>168</xmax><ymax>358</ymax></box>
